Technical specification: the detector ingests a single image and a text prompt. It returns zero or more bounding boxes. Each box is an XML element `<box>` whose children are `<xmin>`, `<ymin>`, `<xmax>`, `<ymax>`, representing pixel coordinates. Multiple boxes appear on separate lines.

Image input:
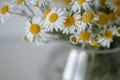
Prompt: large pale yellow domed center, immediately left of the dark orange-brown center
<box><xmin>82</xmin><ymin>12</ymin><xmax>94</xmax><ymax>23</ymax></box>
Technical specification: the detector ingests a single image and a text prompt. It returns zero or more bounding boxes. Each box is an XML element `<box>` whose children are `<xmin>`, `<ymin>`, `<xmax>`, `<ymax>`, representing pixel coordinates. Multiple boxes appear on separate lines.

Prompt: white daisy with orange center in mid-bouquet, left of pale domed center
<box><xmin>60</xmin><ymin>13</ymin><xmax>81</xmax><ymax>34</ymax></box>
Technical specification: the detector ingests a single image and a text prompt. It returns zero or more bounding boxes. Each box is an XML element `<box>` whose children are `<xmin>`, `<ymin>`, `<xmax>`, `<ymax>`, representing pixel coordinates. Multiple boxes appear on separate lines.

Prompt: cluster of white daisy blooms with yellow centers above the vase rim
<box><xmin>0</xmin><ymin>0</ymin><xmax>120</xmax><ymax>48</ymax></box>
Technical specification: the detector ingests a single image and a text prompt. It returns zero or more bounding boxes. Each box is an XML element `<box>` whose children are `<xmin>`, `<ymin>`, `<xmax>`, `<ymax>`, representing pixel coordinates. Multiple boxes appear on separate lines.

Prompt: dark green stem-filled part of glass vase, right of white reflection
<box><xmin>87</xmin><ymin>47</ymin><xmax>120</xmax><ymax>80</ymax></box>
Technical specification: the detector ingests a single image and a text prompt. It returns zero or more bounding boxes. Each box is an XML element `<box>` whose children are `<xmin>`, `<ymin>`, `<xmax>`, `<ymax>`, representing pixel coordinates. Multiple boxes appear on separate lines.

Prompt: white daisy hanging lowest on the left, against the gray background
<box><xmin>25</xmin><ymin>17</ymin><xmax>45</xmax><ymax>44</ymax></box>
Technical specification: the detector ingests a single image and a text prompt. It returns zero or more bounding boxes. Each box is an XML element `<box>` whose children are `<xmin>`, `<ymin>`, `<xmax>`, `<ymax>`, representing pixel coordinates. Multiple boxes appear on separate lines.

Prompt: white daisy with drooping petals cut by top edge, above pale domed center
<box><xmin>72</xmin><ymin>0</ymin><xmax>92</xmax><ymax>12</ymax></box>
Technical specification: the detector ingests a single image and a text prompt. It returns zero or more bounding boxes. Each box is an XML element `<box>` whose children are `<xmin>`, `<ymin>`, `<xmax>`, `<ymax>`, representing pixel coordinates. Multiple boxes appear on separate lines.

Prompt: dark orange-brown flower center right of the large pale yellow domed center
<box><xmin>97</xmin><ymin>13</ymin><xmax>108</xmax><ymax>25</ymax></box>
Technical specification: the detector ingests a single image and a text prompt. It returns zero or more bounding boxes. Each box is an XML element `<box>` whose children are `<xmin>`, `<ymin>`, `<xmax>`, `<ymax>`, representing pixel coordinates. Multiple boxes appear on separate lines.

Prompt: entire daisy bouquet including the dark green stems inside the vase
<box><xmin>0</xmin><ymin>0</ymin><xmax>120</xmax><ymax>80</ymax></box>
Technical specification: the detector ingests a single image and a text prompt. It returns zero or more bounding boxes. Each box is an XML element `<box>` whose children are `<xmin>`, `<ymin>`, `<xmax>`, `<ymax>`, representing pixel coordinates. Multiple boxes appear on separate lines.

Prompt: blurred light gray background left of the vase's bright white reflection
<box><xmin>0</xmin><ymin>16</ymin><xmax>69</xmax><ymax>80</ymax></box>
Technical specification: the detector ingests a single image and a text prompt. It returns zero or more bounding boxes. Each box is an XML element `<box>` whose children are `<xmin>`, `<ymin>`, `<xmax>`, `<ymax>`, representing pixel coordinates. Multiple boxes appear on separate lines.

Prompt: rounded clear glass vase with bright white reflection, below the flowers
<box><xmin>40</xmin><ymin>43</ymin><xmax>120</xmax><ymax>80</ymax></box>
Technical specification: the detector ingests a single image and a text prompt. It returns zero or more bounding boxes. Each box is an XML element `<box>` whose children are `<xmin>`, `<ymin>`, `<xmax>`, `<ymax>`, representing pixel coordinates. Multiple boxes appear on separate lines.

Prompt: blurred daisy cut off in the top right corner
<box><xmin>106</xmin><ymin>0</ymin><xmax>120</xmax><ymax>10</ymax></box>
